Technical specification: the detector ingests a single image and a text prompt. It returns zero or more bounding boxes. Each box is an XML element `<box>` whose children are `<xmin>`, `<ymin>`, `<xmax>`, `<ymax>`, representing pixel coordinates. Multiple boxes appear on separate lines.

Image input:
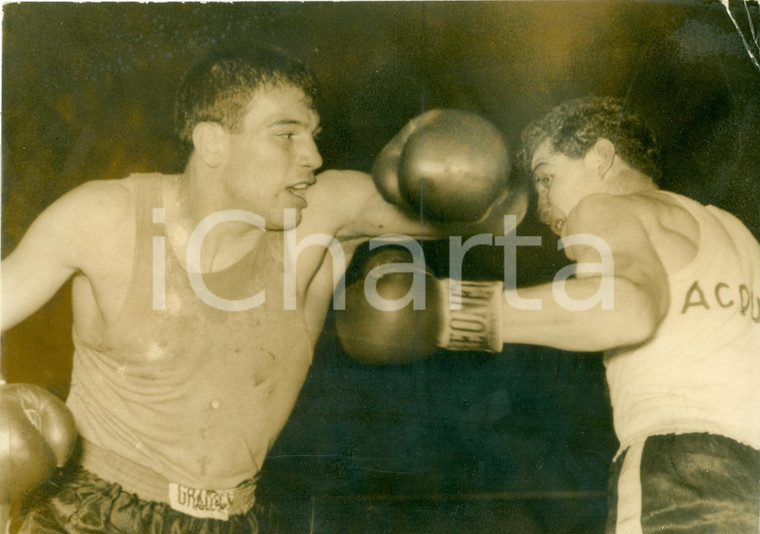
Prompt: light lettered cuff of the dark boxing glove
<box><xmin>438</xmin><ymin>280</ymin><xmax>504</xmax><ymax>352</ymax></box>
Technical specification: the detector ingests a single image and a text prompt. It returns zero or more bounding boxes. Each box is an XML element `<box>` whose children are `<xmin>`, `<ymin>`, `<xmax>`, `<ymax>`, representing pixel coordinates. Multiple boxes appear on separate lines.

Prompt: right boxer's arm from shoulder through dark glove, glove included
<box><xmin>336</xmin><ymin>197</ymin><xmax>669</xmax><ymax>364</ymax></box>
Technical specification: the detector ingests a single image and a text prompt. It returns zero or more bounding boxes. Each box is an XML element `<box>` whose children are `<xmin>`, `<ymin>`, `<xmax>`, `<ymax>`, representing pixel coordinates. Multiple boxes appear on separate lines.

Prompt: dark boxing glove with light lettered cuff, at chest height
<box><xmin>335</xmin><ymin>248</ymin><xmax>503</xmax><ymax>365</ymax></box>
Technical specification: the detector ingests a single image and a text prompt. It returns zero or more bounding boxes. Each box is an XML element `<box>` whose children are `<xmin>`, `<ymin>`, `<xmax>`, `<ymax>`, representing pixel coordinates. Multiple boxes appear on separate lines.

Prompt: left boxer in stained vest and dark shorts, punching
<box><xmin>0</xmin><ymin>50</ymin><xmax>525</xmax><ymax>533</ymax></box>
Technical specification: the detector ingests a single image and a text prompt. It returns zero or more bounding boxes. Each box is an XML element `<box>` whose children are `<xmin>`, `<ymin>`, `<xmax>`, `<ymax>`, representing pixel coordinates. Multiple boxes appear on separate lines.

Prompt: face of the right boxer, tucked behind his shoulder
<box><xmin>531</xmin><ymin>140</ymin><xmax>598</xmax><ymax>234</ymax></box>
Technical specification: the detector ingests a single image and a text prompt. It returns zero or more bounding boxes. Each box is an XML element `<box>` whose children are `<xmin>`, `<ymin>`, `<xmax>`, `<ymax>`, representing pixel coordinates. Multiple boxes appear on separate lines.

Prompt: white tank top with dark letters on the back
<box><xmin>605</xmin><ymin>193</ymin><xmax>760</xmax><ymax>451</ymax></box>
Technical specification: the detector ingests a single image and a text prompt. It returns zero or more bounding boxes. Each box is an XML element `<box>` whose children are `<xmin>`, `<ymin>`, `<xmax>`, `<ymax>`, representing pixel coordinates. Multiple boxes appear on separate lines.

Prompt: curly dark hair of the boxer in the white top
<box><xmin>518</xmin><ymin>96</ymin><xmax>661</xmax><ymax>182</ymax></box>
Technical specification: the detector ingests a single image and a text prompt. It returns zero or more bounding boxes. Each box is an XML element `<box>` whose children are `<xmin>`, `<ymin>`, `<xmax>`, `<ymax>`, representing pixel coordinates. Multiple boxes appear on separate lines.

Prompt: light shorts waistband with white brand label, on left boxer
<box><xmin>81</xmin><ymin>438</ymin><xmax>256</xmax><ymax>519</ymax></box>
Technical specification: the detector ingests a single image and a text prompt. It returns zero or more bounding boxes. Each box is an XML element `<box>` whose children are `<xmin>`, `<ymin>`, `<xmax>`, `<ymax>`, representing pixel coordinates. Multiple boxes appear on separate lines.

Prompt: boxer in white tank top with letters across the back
<box><xmin>339</xmin><ymin>98</ymin><xmax>760</xmax><ymax>534</ymax></box>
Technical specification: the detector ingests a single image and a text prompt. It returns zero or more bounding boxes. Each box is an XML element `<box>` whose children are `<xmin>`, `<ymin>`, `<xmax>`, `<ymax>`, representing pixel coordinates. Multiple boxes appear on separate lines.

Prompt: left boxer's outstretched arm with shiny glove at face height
<box><xmin>308</xmin><ymin>109</ymin><xmax>528</xmax><ymax>239</ymax></box>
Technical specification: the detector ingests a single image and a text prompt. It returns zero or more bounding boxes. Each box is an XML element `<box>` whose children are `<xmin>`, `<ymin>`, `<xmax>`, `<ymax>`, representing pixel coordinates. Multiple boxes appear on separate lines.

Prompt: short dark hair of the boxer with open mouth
<box><xmin>175</xmin><ymin>47</ymin><xmax>318</xmax><ymax>148</ymax></box>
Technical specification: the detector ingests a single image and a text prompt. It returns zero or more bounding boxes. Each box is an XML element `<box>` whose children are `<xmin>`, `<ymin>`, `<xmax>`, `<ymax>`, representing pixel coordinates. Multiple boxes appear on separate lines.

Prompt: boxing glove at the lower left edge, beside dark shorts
<box><xmin>0</xmin><ymin>384</ymin><xmax>77</xmax><ymax>503</ymax></box>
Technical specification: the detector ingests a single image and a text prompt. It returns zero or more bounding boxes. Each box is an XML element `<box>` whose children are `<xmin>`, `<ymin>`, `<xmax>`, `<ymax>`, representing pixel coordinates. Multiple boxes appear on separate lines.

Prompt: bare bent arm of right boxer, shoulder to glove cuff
<box><xmin>503</xmin><ymin>196</ymin><xmax>669</xmax><ymax>352</ymax></box>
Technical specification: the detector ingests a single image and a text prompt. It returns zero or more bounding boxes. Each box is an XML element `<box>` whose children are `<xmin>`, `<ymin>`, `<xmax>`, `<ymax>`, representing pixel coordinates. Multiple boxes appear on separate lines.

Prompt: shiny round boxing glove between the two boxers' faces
<box><xmin>372</xmin><ymin>109</ymin><xmax>511</xmax><ymax>222</ymax></box>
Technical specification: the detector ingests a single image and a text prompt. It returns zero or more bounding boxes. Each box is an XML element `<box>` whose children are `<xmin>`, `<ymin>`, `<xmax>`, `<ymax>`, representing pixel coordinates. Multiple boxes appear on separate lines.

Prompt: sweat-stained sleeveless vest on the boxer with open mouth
<box><xmin>67</xmin><ymin>175</ymin><xmax>313</xmax><ymax>488</ymax></box>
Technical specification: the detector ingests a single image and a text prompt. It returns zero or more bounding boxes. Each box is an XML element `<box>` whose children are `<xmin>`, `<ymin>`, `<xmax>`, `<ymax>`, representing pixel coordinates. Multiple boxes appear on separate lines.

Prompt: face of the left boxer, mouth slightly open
<box><xmin>218</xmin><ymin>86</ymin><xmax>322</xmax><ymax>230</ymax></box>
